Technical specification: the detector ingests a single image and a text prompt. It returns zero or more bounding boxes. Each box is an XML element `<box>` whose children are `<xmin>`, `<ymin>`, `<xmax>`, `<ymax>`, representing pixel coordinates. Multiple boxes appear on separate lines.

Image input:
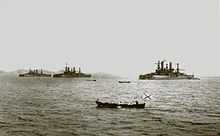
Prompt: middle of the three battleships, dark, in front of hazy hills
<box><xmin>53</xmin><ymin>65</ymin><xmax>92</xmax><ymax>78</ymax></box>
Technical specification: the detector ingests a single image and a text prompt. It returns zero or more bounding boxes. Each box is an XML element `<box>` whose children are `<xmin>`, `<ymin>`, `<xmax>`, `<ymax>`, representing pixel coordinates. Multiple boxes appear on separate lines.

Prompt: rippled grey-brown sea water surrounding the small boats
<box><xmin>0</xmin><ymin>75</ymin><xmax>220</xmax><ymax>136</ymax></box>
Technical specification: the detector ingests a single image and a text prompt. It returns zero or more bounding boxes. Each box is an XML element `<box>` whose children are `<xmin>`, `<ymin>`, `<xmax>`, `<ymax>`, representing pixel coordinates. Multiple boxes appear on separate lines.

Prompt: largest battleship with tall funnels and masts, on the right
<box><xmin>139</xmin><ymin>60</ymin><xmax>199</xmax><ymax>80</ymax></box>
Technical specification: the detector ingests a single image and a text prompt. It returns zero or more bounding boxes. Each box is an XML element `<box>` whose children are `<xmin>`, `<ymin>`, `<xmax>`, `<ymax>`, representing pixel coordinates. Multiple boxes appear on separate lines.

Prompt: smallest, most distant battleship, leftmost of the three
<box><xmin>18</xmin><ymin>69</ymin><xmax>51</xmax><ymax>77</ymax></box>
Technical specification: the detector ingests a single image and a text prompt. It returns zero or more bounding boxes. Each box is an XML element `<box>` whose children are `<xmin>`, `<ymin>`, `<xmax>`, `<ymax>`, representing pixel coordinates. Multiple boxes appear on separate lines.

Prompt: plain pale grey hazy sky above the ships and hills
<box><xmin>0</xmin><ymin>0</ymin><xmax>220</xmax><ymax>77</ymax></box>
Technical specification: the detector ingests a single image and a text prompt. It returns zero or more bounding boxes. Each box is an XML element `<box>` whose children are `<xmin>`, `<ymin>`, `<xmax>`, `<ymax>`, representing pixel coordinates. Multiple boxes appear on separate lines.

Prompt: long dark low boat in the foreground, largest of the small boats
<box><xmin>96</xmin><ymin>100</ymin><xmax>145</xmax><ymax>108</ymax></box>
